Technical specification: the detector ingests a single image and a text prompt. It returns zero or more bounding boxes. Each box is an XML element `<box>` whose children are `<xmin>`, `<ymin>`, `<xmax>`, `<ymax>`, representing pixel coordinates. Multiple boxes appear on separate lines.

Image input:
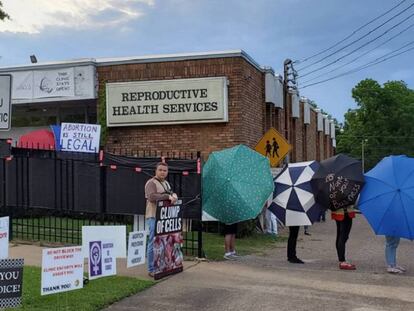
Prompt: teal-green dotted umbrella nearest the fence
<box><xmin>203</xmin><ymin>145</ymin><xmax>274</xmax><ymax>224</ymax></box>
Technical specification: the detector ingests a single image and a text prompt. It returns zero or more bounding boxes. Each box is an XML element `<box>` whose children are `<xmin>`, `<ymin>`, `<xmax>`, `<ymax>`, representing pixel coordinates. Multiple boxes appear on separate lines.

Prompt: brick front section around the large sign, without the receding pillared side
<box><xmin>98</xmin><ymin>57</ymin><xmax>265</xmax><ymax>156</ymax></box>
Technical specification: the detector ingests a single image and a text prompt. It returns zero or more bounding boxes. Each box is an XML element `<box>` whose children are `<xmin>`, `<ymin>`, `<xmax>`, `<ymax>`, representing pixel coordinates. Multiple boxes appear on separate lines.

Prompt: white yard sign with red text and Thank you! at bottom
<box><xmin>40</xmin><ymin>246</ymin><xmax>83</xmax><ymax>295</ymax></box>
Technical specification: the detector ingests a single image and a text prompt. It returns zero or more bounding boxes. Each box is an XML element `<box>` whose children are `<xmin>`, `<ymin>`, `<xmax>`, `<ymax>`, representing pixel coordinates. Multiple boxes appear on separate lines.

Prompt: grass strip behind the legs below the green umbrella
<box><xmin>203</xmin><ymin>233</ymin><xmax>286</xmax><ymax>260</ymax></box>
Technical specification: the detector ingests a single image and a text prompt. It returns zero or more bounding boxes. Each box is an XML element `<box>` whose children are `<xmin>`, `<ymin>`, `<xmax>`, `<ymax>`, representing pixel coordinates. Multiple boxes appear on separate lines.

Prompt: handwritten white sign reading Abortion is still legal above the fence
<box><xmin>60</xmin><ymin>123</ymin><xmax>101</xmax><ymax>153</ymax></box>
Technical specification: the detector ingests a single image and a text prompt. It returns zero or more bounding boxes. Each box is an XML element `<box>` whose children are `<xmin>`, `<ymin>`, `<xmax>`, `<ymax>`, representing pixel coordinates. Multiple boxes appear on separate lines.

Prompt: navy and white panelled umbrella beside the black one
<box><xmin>269</xmin><ymin>161</ymin><xmax>321</xmax><ymax>226</ymax></box>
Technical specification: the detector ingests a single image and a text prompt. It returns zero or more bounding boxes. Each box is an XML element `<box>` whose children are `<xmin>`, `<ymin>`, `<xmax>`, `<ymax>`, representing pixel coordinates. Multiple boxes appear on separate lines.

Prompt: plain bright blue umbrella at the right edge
<box><xmin>359</xmin><ymin>155</ymin><xmax>414</xmax><ymax>240</ymax></box>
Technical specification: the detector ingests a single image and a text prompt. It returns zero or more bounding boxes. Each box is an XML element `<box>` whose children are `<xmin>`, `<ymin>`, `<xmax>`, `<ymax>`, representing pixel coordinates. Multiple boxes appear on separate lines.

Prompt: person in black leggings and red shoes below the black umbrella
<box><xmin>331</xmin><ymin>205</ymin><xmax>356</xmax><ymax>270</ymax></box>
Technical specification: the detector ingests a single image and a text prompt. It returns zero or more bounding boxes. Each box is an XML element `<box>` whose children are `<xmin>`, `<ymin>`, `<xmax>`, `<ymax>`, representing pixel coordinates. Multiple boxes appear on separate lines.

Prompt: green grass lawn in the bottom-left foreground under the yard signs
<box><xmin>7</xmin><ymin>266</ymin><xmax>155</xmax><ymax>311</ymax></box>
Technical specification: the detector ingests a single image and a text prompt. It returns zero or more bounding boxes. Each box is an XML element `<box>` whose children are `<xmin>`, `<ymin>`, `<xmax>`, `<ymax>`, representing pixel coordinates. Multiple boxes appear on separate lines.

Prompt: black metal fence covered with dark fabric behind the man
<box><xmin>0</xmin><ymin>141</ymin><xmax>202</xmax><ymax>257</ymax></box>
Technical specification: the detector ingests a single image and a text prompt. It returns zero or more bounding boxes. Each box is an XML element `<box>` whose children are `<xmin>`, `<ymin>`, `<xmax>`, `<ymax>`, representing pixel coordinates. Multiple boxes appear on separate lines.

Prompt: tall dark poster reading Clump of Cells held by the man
<box><xmin>153</xmin><ymin>200</ymin><xmax>183</xmax><ymax>280</ymax></box>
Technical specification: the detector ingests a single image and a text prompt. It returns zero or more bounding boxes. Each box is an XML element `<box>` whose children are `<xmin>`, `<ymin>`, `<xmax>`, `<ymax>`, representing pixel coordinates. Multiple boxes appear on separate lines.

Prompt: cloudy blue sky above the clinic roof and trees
<box><xmin>0</xmin><ymin>0</ymin><xmax>414</xmax><ymax>122</ymax></box>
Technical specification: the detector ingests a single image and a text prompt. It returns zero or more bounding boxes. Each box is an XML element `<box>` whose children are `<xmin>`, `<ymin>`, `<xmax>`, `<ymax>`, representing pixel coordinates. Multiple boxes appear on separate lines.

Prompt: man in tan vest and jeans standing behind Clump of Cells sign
<box><xmin>145</xmin><ymin>162</ymin><xmax>177</xmax><ymax>277</ymax></box>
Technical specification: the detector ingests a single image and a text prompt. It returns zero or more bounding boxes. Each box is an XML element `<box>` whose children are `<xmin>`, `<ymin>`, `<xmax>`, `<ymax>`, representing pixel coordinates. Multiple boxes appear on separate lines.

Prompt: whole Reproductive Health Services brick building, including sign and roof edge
<box><xmin>0</xmin><ymin>50</ymin><xmax>335</xmax><ymax>162</ymax></box>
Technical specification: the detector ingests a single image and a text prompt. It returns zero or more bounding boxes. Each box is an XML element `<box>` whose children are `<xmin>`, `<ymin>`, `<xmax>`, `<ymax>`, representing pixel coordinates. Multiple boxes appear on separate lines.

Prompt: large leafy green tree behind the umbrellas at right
<box><xmin>337</xmin><ymin>79</ymin><xmax>414</xmax><ymax>169</ymax></box>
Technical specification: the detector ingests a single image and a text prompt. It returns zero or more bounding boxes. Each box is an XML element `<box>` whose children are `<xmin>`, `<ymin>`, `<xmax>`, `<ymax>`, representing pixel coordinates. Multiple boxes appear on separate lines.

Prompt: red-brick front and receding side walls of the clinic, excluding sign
<box><xmin>97</xmin><ymin>57</ymin><xmax>332</xmax><ymax>162</ymax></box>
